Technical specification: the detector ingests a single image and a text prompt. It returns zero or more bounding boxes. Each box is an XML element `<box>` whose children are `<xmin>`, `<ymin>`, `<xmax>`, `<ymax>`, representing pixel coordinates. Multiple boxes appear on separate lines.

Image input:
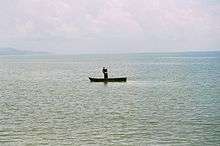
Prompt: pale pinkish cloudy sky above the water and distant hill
<box><xmin>0</xmin><ymin>0</ymin><xmax>220</xmax><ymax>54</ymax></box>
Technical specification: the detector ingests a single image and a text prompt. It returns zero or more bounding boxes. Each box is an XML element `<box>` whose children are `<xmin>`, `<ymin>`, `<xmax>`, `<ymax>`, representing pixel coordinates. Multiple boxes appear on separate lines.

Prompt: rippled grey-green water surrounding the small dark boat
<box><xmin>0</xmin><ymin>52</ymin><xmax>220</xmax><ymax>146</ymax></box>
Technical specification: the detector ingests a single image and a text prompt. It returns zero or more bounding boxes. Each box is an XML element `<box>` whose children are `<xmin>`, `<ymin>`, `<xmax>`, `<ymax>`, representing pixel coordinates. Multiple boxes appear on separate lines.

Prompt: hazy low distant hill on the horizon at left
<box><xmin>0</xmin><ymin>48</ymin><xmax>48</xmax><ymax>55</ymax></box>
